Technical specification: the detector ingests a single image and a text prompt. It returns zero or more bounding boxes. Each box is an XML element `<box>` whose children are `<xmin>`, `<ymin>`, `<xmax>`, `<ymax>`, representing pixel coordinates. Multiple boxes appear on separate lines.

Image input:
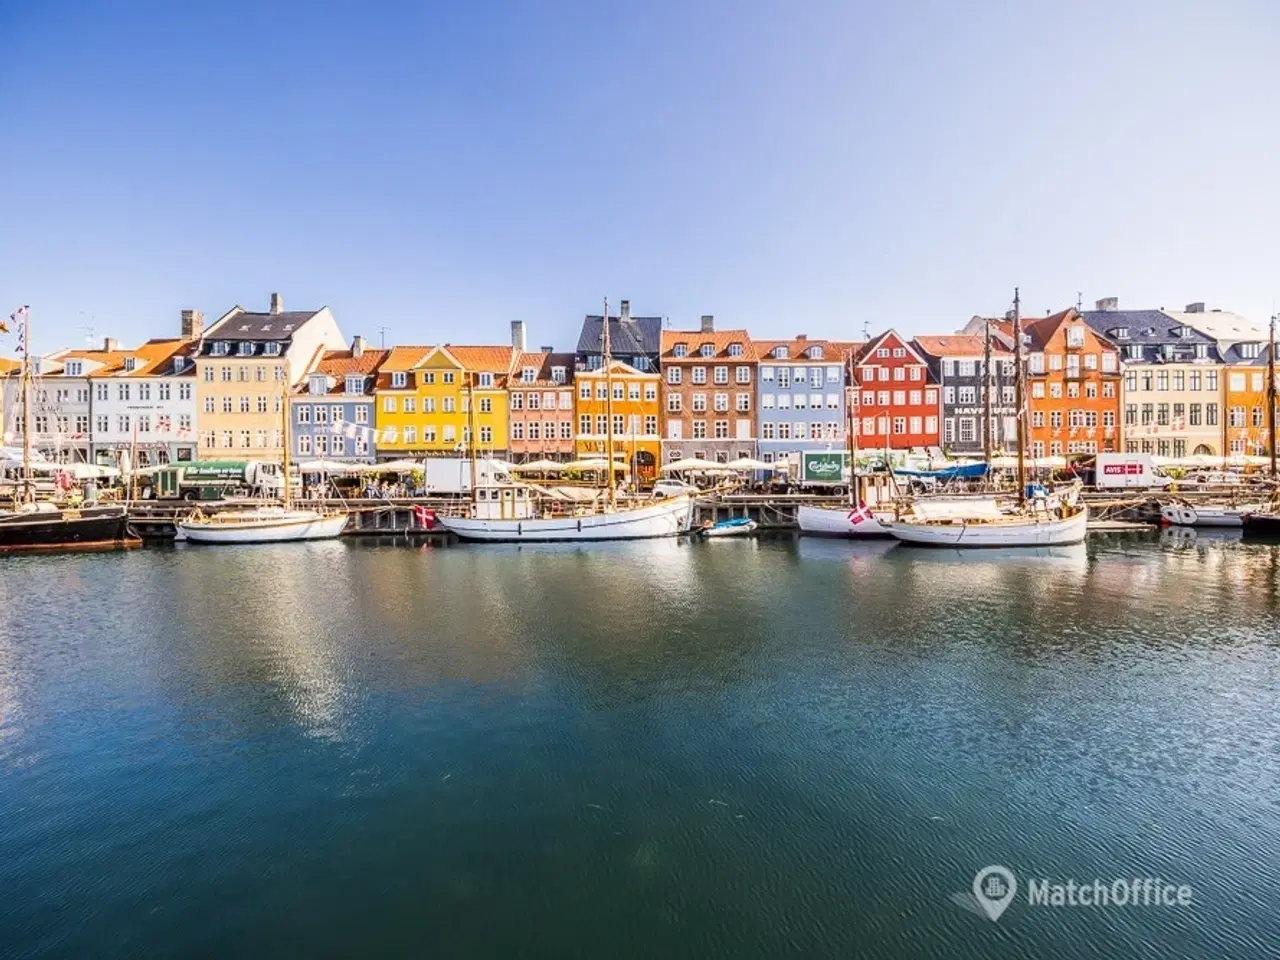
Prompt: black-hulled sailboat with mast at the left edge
<box><xmin>0</xmin><ymin>306</ymin><xmax>142</xmax><ymax>553</ymax></box>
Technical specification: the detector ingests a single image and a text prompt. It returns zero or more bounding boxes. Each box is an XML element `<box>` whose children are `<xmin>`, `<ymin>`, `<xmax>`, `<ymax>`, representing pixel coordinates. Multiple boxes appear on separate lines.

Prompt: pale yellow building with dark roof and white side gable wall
<box><xmin>195</xmin><ymin>293</ymin><xmax>347</xmax><ymax>460</ymax></box>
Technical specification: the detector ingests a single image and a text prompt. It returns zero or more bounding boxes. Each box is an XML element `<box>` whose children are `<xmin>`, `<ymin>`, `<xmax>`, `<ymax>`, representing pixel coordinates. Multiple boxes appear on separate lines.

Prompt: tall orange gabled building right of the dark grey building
<box><xmin>1004</xmin><ymin>307</ymin><xmax>1124</xmax><ymax>457</ymax></box>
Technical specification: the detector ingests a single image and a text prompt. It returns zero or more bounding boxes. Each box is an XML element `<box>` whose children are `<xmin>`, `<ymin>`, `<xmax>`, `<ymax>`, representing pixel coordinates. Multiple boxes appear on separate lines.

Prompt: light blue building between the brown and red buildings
<box><xmin>753</xmin><ymin>337</ymin><xmax>850</xmax><ymax>476</ymax></box>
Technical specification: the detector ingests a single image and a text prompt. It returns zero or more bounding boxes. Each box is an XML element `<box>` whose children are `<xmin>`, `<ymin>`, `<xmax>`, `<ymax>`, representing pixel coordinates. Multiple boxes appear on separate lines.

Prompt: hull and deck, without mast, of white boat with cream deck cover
<box><xmin>886</xmin><ymin>498</ymin><xmax>1089</xmax><ymax>548</ymax></box>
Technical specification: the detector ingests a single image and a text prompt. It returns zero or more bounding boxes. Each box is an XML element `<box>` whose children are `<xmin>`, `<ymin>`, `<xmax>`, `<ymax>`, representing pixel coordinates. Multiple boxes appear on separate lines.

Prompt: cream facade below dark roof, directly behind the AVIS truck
<box><xmin>1120</xmin><ymin>361</ymin><xmax>1225</xmax><ymax>457</ymax></box>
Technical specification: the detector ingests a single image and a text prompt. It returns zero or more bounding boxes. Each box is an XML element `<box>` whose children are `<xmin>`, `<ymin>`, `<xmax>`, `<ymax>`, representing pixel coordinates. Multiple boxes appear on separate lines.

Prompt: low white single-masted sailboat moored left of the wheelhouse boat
<box><xmin>177</xmin><ymin>376</ymin><xmax>347</xmax><ymax>544</ymax></box>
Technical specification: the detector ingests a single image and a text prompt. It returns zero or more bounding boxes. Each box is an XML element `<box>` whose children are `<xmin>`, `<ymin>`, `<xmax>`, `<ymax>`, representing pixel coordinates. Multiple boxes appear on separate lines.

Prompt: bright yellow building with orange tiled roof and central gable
<box><xmin>375</xmin><ymin>343</ymin><xmax>517</xmax><ymax>461</ymax></box>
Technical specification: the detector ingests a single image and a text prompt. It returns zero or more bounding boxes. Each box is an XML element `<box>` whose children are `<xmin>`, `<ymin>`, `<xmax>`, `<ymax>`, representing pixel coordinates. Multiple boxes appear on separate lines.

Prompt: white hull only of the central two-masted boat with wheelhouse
<box><xmin>439</xmin><ymin>497</ymin><xmax>694</xmax><ymax>543</ymax></box>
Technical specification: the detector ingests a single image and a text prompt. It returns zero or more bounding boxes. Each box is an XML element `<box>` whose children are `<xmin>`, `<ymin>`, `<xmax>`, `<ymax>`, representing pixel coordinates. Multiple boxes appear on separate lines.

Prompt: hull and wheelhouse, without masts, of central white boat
<box><xmin>436</xmin><ymin>483</ymin><xmax>694</xmax><ymax>543</ymax></box>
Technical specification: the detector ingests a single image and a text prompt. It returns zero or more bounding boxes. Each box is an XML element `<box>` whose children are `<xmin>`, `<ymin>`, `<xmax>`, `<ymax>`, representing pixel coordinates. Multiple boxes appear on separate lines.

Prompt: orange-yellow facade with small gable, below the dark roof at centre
<box><xmin>575</xmin><ymin>360</ymin><xmax>662</xmax><ymax>484</ymax></box>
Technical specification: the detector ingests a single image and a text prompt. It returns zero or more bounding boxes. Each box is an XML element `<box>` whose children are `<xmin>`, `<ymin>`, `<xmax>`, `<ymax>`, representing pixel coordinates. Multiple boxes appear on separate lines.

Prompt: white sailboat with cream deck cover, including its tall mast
<box><xmin>884</xmin><ymin>289</ymin><xmax>1089</xmax><ymax>548</ymax></box>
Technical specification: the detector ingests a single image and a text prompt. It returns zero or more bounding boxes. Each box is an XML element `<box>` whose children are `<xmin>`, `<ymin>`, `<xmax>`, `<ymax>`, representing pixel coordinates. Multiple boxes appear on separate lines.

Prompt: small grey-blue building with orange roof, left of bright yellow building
<box><xmin>289</xmin><ymin>337</ymin><xmax>390</xmax><ymax>463</ymax></box>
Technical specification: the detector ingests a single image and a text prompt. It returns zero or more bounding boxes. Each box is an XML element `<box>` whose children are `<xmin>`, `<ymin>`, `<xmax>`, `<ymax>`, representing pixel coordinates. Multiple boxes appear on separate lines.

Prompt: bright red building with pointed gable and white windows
<box><xmin>850</xmin><ymin>330</ymin><xmax>942</xmax><ymax>451</ymax></box>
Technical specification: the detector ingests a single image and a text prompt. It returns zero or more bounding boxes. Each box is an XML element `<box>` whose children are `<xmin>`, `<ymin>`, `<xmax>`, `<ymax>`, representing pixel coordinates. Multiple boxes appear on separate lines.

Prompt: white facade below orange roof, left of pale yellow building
<box><xmin>90</xmin><ymin>375</ymin><xmax>200</xmax><ymax>465</ymax></box>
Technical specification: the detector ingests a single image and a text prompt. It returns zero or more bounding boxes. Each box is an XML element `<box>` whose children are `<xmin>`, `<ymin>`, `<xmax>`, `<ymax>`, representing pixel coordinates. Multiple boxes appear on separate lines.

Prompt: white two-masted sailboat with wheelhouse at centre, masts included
<box><xmin>439</xmin><ymin>301</ymin><xmax>694</xmax><ymax>543</ymax></box>
